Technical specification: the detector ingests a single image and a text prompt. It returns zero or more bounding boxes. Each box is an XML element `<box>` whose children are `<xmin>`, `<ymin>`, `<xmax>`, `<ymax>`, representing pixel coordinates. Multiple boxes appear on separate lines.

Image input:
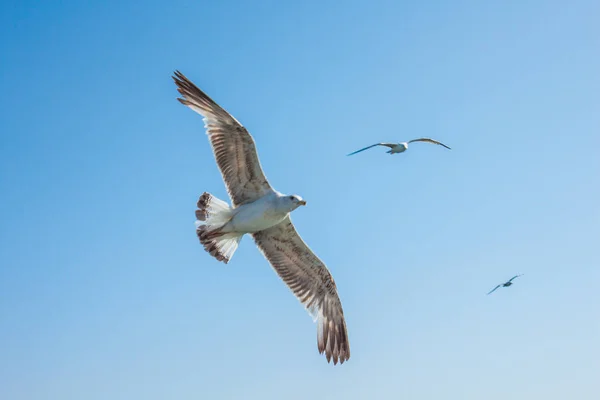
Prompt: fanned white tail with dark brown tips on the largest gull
<box><xmin>196</xmin><ymin>192</ymin><xmax>243</xmax><ymax>264</ymax></box>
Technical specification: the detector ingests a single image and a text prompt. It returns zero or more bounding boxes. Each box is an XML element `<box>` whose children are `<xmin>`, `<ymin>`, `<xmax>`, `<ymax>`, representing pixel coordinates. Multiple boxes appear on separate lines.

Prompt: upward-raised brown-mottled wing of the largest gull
<box><xmin>173</xmin><ymin>71</ymin><xmax>273</xmax><ymax>206</ymax></box>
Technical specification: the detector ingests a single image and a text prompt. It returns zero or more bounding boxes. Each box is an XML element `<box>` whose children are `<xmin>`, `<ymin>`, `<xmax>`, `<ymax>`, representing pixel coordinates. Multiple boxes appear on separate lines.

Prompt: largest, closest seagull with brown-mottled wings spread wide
<box><xmin>173</xmin><ymin>71</ymin><xmax>350</xmax><ymax>364</ymax></box>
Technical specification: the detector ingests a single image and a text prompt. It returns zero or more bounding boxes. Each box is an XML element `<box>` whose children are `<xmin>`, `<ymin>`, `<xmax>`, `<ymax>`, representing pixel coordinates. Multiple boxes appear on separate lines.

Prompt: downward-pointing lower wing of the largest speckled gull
<box><xmin>252</xmin><ymin>216</ymin><xmax>350</xmax><ymax>364</ymax></box>
